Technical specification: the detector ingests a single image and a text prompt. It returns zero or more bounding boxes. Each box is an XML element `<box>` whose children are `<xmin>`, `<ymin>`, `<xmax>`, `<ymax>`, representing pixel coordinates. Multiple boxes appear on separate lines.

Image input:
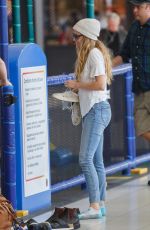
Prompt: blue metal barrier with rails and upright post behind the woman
<box><xmin>47</xmin><ymin>64</ymin><xmax>150</xmax><ymax>193</ymax></box>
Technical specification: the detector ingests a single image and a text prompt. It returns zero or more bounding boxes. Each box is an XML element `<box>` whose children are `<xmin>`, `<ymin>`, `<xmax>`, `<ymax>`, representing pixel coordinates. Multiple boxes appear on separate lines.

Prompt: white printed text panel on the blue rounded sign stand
<box><xmin>21</xmin><ymin>66</ymin><xmax>50</xmax><ymax>197</ymax></box>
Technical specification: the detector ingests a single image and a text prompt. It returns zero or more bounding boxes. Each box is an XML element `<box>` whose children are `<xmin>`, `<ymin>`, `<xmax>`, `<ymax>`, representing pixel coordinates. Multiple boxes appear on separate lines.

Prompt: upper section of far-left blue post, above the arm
<box><xmin>0</xmin><ymin>0</ymin><xmax>8</xmax><ymax>73</ymax></box>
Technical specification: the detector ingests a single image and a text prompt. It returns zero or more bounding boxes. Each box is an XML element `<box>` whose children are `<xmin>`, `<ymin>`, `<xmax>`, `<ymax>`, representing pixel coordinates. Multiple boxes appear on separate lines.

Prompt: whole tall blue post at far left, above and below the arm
<box><xmin>0</xmin><ymin>0</ymin><xmax>16</xmax><ymax>208</ymax></box>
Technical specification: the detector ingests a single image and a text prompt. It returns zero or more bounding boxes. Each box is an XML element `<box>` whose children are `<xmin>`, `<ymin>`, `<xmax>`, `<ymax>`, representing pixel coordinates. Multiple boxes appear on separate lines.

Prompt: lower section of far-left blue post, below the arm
<box><xmin>2</xmin><ymin>86</ymin><xmax>16</xmax><ymax>208</ymax></box>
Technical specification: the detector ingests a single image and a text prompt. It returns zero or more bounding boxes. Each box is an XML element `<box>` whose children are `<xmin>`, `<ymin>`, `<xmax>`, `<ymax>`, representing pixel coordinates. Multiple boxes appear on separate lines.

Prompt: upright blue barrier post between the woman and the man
<box><xmin>125</xmin><ymin>71</ymin><xmax>136</xmax><ymax>174</ymax></box>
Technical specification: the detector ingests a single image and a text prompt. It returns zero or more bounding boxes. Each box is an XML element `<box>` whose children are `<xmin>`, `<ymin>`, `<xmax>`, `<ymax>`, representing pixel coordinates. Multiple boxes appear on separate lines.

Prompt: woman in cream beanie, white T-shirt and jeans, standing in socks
<box><xmin>65</xmin><ymin>18</ymin><xmax>112</xmax><ymax>219</ymax></box>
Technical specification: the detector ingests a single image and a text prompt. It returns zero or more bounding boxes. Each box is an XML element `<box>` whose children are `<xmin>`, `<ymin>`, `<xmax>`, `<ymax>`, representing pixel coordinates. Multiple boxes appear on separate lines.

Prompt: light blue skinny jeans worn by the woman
<box><xmin>79</xmin><ymin>101</ymin><xmax>111</xmax><ymax>203</ymax></box>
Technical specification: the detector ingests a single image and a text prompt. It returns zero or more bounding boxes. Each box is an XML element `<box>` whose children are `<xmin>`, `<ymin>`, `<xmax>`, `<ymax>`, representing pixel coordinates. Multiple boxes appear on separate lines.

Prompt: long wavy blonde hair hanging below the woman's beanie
<box><xmin>75</xmin><ymin>36</ymin><xmax>112</xmax><ymax>85</ymax></box>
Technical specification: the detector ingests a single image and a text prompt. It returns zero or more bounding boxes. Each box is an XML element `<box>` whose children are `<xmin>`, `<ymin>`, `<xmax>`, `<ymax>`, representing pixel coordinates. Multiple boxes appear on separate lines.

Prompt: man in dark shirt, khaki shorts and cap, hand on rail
<box><xmin>113</xmin><ymin>0</ymin><xmax>150</xmax><ymax>185</ymax></box>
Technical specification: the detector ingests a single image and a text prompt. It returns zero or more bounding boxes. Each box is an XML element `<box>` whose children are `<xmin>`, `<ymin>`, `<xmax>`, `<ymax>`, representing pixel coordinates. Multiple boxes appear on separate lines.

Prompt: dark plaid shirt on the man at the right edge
<box><xmin>120</xmin><ymin>19</ymin><xmax>150</xmax><ymax>94</ymax></box>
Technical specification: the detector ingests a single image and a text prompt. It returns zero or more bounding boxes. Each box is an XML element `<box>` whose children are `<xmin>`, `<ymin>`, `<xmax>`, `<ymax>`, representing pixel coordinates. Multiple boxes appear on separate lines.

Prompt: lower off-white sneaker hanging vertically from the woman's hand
<box><xmin>71</xmin><ymin>102</ymin><xmax>82</xmax><ymax>126</ymax></box>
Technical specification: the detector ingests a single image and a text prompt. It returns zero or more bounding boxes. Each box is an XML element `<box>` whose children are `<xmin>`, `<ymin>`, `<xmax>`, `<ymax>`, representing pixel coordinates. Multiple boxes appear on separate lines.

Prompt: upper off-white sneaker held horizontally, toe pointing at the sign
<box><xmin>52</xmin><ymin>90</ymin><xmax>79</xmax><ymax>102</ymax></box>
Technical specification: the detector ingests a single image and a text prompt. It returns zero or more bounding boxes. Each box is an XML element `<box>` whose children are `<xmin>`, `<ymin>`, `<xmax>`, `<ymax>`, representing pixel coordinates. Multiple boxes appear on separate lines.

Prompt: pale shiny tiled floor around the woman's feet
<box><xmin>35</xmin><ymin>175</ymin><xmax>150</xmax><ymax>230</ymax></box>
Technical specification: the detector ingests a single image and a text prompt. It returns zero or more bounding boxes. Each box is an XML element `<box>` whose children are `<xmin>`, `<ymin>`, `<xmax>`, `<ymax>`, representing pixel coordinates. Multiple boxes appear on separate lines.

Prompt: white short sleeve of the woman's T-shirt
<box><xmin>88</xmin><ymin>48</ymin><xmax>105</xmax><ymax>78</ymax></box>
